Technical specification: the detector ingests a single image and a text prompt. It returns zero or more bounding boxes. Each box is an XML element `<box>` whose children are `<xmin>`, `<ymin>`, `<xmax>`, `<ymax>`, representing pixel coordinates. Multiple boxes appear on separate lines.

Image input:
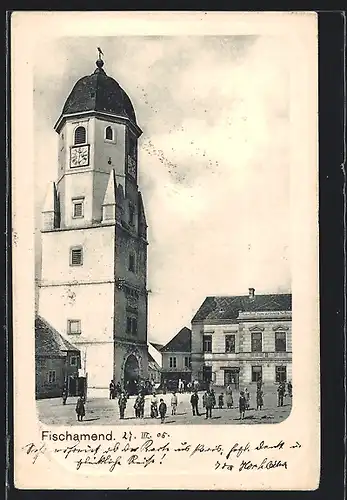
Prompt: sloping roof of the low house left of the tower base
<box><xmin>35</xmin><ymin>316</ymin><xmax>80</xmax><ymax>358</ymax></box>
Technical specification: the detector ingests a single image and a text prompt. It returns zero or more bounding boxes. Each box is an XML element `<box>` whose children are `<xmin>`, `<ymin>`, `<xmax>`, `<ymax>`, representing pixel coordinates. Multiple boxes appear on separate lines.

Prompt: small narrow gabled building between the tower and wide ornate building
<box><xmin>161</xmin><ymin>327</ymin><xmax>192</xmax><ymax>389</ymax></box>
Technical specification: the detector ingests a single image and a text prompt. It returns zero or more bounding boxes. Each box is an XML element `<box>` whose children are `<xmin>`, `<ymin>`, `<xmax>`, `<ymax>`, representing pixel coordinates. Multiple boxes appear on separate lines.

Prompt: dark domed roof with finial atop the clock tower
<box><xmin>58</xmin><ymin>59</ymin><xmax>136</xmax><ymax>124</ymax></box>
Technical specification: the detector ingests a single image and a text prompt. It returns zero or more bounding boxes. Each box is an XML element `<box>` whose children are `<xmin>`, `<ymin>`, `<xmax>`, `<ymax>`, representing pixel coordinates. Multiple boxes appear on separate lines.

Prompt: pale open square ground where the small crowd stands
<box><xmin>36</xmin><ymin>386</ymin><xmax>292</xmax><ymax>426</ymax></box>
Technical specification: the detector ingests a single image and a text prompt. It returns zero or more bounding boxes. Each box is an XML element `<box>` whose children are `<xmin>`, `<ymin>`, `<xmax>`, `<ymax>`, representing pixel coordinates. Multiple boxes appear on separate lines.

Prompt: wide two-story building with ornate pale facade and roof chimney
<box><xmin>191</xmin><ymin>288</ymin><xmax>292</xmax><ymax>388</ymax></box>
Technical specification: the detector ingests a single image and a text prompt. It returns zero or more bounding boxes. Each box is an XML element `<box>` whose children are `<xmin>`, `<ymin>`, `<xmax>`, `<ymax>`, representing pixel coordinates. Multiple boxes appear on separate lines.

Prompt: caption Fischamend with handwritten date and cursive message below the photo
<box><xmin>23</xmin><ymin>430</ymin><xmax>301</xmax><ymax>473</ymax></box>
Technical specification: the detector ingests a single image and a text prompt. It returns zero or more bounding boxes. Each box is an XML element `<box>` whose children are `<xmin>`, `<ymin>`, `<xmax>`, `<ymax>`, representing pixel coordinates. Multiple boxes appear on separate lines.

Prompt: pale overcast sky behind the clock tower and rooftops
<box><xmin>34</xmin><ymin>36</ymin><xmax>290</xmax><ymax>343</ymax></box>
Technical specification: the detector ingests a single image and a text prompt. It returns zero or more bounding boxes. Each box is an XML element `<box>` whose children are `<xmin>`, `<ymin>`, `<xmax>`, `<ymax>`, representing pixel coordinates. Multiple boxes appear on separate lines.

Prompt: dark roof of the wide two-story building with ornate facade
<box><xmin>192</xmin><ymin>293</ymin><xmax>292</xmax><ymax>322</ymax></box>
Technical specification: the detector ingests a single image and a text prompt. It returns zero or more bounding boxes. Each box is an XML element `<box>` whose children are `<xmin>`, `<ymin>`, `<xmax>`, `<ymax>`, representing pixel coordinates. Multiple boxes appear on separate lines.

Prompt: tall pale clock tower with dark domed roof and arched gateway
<box><xmin>39</xmin><ymin>59</ymin><xmax>148</xmax><ymax>393</ymax></box>
